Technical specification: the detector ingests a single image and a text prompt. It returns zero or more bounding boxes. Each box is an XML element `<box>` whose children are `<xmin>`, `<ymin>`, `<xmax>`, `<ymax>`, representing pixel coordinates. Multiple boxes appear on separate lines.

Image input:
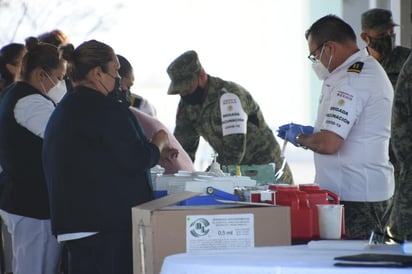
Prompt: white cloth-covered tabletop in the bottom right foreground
<box><xmin>161</xmin><ymin>242</ymin><xmax>412</xmax><ymax>274</ymax></box>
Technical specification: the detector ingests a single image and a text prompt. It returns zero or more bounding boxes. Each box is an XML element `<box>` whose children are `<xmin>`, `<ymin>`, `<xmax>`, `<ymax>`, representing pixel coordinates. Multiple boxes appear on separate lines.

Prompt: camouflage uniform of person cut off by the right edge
<box><xmin>390</xmin><ymin>55</ymin><xmax>412</xmax><ymax>240</ymax></box>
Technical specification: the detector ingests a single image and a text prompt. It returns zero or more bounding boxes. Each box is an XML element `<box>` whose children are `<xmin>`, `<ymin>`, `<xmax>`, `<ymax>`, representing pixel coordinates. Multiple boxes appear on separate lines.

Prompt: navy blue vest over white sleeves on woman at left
<box><xmin>0</xmin><ymin>82</ymin><xmax>54</xmax><ymax>219</ymax></box>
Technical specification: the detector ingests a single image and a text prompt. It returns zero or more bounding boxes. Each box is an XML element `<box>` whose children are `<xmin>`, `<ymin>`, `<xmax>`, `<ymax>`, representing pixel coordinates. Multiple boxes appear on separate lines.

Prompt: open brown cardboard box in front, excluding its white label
<box><xmin>132</xmin><ymin>192</ymin><xmax>291</xmax><ymax>274</ymax></box>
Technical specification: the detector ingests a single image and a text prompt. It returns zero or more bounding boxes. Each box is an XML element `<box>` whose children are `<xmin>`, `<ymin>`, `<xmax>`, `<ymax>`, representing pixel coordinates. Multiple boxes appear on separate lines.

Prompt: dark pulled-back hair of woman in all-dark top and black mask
<box><xmin>61</xmin><ymin>40</ymin><xmax>115</xmax><ymax>82</ymax></box>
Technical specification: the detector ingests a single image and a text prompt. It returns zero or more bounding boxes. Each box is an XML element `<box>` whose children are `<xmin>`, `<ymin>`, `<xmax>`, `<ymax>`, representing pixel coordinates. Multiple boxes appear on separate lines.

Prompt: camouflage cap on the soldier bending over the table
<box><xmin>167</xmin><ymin>50</ymin><xmax>202</xmax><ymax>94</ymax></box>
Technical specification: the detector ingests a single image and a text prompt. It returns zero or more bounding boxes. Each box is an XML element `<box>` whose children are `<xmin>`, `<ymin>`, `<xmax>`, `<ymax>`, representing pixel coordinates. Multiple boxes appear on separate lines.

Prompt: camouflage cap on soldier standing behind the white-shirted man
<box><xmin>361</xmin><ymin>9</ymin><xmax>399</xmax><ymax>32</ymax></box>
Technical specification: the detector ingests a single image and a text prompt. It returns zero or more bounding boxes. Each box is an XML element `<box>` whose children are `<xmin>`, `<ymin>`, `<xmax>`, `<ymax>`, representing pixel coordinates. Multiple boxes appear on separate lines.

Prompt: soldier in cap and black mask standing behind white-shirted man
<box><xmin>361</xmin><ymin>9</ymin><xmax>412</xmax><ymax>241</ymax></box>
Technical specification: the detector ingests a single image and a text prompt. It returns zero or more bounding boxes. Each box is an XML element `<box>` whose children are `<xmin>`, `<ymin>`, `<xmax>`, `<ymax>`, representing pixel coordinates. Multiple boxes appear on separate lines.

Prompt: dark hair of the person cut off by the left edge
<box><xmin>0</xmin><ymin>43</ymin><xmax>25</xmax><ymax>87</ymax></box>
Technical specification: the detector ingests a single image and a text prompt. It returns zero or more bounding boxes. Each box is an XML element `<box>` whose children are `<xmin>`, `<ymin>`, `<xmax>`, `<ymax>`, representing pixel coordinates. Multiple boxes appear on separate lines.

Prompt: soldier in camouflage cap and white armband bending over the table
<box><xmin>167</xmin><ymin>51</ymin><xmax>293</xmax><ymax>183</ymax></box>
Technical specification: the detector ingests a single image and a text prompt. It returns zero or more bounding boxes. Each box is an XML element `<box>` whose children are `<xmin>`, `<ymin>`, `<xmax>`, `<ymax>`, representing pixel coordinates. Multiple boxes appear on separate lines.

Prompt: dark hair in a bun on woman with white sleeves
<box><xmin>20</xmin><ymin>37</ymin><xmax>60</xmax><ymax>81</ymax></box>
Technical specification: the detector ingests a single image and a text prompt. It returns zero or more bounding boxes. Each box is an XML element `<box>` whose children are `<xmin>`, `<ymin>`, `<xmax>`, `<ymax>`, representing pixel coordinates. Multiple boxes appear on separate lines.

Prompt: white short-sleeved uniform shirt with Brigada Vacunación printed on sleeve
<box><xmin>314</xmin><ymin>51</ymin><xmax>394</xmax><ymax>202</ymax></box>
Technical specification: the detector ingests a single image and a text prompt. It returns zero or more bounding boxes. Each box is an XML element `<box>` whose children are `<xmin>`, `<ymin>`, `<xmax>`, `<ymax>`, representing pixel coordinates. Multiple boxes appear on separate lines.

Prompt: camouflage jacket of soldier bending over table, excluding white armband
<box><xmin>174</xmin><ymin>76</ymin><xmax>293</xmax><ymax>183</ymax></box>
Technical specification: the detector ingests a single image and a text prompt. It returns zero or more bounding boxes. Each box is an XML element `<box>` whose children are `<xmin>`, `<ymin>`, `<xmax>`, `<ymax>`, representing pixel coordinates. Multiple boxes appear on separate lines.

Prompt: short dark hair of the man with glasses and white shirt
<box><xmin>305</xmin><ymin>15</ymin><xmax>356</xmax><ymax>45</ymax></box>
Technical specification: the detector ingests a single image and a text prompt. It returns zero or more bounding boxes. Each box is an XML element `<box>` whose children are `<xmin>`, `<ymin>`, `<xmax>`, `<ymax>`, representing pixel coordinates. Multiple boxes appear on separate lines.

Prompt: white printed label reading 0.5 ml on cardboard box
<box><xmin>186</xmin><ymin>214</ymin><xmax>255</xmax><ymax>252</ymax></box>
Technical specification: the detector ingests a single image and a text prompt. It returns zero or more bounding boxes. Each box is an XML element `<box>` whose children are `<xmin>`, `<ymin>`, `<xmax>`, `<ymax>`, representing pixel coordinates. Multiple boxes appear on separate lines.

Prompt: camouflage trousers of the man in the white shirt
<box><xmin>341</xmin><ymin>199</ymin><xmax>392</xmax><ymax>240</ymax></box>
